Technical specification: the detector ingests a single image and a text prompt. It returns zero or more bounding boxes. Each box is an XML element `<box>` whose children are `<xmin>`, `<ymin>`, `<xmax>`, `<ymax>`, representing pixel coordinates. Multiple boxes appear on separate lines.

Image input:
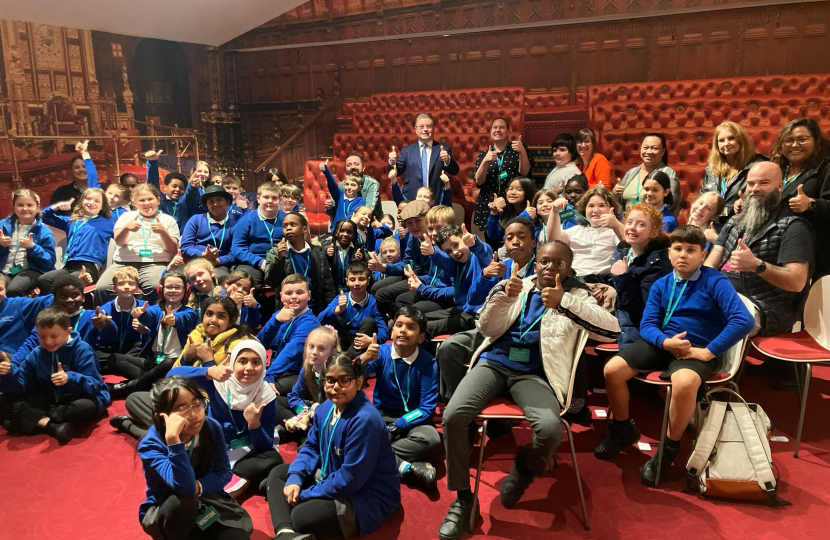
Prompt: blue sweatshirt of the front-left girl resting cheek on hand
<box><xmin>138</xmin><ymin>416</ymin><xmax>233</xmax><ymax>522</ymax></box>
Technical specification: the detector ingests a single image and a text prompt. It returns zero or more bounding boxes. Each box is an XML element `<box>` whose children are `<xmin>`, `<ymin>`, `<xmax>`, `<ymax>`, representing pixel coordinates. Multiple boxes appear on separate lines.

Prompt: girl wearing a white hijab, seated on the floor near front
<box><xmin>168</xmin><ymin>339</ymin><xmax>283</xmax><ymax>497</ymax></box>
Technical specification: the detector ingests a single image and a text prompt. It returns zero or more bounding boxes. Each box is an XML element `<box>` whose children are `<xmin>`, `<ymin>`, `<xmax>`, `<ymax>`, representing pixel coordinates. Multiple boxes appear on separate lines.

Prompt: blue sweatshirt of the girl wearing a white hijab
<box><xmin>167</xmin><ymin>366</ymin><xmax>277</xmax><ymax>452</ymax></box>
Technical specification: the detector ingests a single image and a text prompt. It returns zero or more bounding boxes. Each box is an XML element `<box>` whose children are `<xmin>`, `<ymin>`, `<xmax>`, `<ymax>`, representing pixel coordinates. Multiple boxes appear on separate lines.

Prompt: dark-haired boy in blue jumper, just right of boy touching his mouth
<box><xmin>317</xmin><ymin>261</ymin><xmax>389</xmax><ymax>356</ymax></box>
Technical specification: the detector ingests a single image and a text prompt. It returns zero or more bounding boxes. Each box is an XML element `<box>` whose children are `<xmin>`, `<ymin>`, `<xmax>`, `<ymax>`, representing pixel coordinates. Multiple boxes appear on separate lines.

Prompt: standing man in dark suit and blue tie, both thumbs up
<box><xmin>389</xmin><ymin>113</ymin><xmax>458</xmax><ymax>205</ymax></box>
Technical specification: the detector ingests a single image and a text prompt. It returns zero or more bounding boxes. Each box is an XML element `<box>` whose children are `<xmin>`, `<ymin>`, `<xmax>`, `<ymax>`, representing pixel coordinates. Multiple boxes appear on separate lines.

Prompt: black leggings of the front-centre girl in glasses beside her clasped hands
<box><xmin>268</xmin><ymin>463</ymin><xmax>343</xmax><ymax>538</ymax></box>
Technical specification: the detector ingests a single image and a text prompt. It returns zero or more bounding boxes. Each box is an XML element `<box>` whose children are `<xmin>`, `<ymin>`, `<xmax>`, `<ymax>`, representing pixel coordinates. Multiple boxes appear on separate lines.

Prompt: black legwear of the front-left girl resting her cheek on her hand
<box><xmin>148</xmin><ymin>495</ymin><xmax>250</xmax><ymax>540</ymax></box>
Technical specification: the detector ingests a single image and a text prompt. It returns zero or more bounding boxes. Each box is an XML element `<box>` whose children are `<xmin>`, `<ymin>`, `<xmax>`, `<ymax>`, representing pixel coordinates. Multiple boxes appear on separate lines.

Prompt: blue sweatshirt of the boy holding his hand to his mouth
<box><xmin>256</xmin><ymin>308</ymin><xmax>320</xmax><ymax>383</ymax></box>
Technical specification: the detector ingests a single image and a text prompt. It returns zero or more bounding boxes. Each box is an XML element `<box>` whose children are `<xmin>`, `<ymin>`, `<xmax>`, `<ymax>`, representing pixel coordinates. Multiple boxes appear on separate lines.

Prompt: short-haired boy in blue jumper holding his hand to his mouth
<box><xmin>256</xmin><ymin>274</ymin><xmax>320</xmax><ymax>396</ymax></box>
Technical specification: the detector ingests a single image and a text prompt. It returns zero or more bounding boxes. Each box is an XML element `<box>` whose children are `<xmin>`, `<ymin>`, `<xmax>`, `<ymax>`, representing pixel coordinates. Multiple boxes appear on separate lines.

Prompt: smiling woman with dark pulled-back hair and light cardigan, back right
<box><xmin>614</xmin><ymin>133</ymin><xmax>683</xmax><ymax>214</ymax></box>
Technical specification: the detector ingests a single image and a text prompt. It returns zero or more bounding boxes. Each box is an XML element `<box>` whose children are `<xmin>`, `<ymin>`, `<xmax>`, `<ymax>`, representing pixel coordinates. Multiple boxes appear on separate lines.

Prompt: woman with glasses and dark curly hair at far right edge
<box><xmin>770</xmin><ymin>118</ymin><xmax>830</xmax><ymax>281</ymax></box>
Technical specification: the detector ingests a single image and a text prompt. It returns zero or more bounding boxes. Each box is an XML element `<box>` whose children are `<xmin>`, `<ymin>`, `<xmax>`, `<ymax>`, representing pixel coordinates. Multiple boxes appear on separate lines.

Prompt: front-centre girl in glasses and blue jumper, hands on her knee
<box><xmin>268</xmin><ymin>354</ymin><xmax>401</xmax><ymax>540</ymax></box>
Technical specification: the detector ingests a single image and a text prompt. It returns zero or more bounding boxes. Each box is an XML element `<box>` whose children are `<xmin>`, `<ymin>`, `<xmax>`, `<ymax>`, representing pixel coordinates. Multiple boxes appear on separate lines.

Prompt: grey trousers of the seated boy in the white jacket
<box><xmin>442</xmin><ymin>363</ymin><xmax>562</xmax><ymax>491</ymax></box>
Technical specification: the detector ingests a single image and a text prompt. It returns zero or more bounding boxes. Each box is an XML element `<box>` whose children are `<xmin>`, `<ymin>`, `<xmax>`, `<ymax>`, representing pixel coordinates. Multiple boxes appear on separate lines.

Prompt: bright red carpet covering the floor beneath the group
<box><xmin>0</xmin><ymin>358</ymin><xmax>830</xmax><ymax>540</ymax></box>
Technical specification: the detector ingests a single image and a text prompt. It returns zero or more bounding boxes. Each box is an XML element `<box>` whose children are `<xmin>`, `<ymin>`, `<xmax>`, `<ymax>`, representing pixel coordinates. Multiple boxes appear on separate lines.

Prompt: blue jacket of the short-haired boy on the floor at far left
<box><xmin>0</xmin><ymin>332</ymin><xmax>110</xmax><ymax>413</ymax></box>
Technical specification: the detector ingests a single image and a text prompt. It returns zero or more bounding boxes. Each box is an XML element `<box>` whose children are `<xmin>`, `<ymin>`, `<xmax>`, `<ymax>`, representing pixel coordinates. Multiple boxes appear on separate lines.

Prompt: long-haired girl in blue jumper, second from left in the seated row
<box><xmin>38</xmin><ymin>188</ymin><xmax>115</xmax><ymax>294</ymax></box>
